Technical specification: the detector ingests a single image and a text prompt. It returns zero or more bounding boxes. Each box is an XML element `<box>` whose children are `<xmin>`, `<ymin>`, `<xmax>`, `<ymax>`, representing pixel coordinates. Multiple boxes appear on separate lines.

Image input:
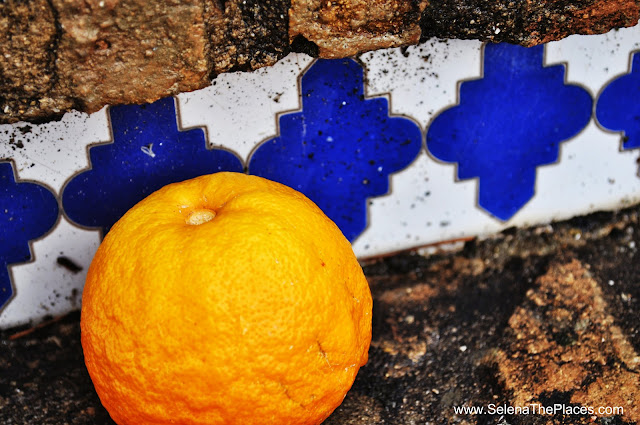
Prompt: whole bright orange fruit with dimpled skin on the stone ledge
<box><xmin>81</xmin><ymin>173</ymin><xmax>372</xmax><ymax>425</ymax></box>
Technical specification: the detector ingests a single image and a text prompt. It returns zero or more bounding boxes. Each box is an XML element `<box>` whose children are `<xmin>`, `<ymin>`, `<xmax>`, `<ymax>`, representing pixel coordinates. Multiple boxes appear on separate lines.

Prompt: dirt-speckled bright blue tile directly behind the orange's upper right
<box><xmin>249</xmin><ymin>59</ymin><xmax>422</xmax><ymax>241</ymax></box>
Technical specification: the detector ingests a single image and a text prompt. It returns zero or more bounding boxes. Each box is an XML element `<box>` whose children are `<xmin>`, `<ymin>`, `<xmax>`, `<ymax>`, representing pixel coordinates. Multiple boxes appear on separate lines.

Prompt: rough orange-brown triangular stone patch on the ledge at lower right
<box><xmin>495</xmin><ymin>259</ymin><xmax>640</xmax><ymax>423</ymax></box>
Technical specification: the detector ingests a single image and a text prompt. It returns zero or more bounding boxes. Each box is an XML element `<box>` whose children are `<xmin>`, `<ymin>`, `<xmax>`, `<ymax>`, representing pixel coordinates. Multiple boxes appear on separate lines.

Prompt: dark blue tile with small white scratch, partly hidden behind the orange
<box><xmin>62</xmin><ymin>98</ymin><xmax>243</xmax><ymax>233</ymax></box>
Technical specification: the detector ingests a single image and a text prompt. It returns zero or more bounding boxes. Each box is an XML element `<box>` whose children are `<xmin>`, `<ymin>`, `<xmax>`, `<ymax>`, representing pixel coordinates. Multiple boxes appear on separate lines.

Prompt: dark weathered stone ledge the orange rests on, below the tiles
<box><xmin>0</xmin><ymin>206</ymin><xmax>640</xmax><ymax>425</ymax></box>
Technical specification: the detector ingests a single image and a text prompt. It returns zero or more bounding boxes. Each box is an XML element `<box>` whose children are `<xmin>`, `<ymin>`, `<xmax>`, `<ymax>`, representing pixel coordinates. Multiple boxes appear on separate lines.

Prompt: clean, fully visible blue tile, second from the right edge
<box><xmin>427</xmin><ymin>44</ymin><xmax>592</xmax><ymax>220</ymax></box>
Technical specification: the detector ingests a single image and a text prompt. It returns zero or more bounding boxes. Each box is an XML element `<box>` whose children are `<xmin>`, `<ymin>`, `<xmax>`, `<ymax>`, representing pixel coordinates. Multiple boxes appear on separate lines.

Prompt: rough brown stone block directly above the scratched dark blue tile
<box><xmin>52</xmin><ymin>0</ymin><xmax>210</xmax><ymax>112</ymax></box>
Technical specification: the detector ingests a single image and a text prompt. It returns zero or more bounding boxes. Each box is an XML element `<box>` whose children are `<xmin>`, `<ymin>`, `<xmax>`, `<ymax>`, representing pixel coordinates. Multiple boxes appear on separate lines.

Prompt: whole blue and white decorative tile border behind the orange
<box><xmin>0</xmin><ymin>27</ymin><xmax>640</xmax><ymax>327</ymax></box>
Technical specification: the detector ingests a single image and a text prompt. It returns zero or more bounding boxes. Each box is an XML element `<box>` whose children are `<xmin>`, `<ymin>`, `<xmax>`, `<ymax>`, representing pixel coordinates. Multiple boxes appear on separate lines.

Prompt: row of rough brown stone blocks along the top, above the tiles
<box><xmin>0</xmin><ymin>0</ymin><xmax>640</xmax><ymax>123</ymax></box>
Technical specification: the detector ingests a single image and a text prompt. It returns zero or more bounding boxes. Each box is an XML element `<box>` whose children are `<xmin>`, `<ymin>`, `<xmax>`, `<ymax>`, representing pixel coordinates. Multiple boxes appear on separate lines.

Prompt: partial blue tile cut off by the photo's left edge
<box><xmin>0</xmin><ymin>162</ymin><xmax>59</xmax><ymax>309</ymax></box>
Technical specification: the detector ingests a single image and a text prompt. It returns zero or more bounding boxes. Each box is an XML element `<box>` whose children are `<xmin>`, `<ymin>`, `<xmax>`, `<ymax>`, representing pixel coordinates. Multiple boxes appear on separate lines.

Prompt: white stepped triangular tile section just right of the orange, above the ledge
<box><xmin>353</xmin><ymin>151</ymin><xmax>503</xmax><ymax>257</ymax></box>
